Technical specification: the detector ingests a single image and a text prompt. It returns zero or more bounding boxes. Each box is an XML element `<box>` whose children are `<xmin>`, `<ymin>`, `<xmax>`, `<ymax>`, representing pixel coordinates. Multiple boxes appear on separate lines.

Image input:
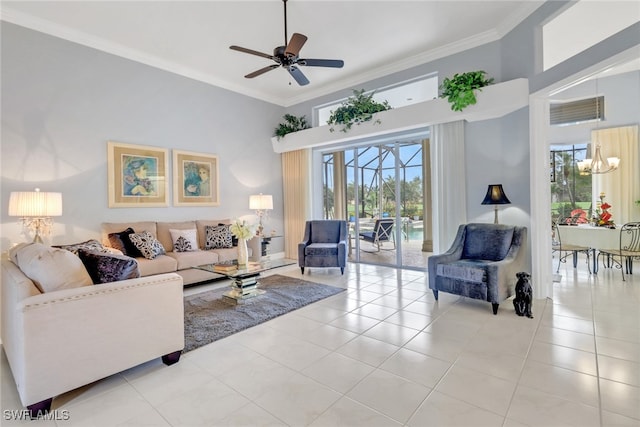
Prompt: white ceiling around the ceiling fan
<box><xmin>1</xmin><ymin>0</ymin><xmax>543</xmax><ymax>106</ymax></box>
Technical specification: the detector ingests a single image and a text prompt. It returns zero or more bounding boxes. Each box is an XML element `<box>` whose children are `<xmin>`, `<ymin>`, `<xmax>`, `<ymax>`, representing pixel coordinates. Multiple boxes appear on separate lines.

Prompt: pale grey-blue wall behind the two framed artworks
<box><xmin>0</xmin><ymin>22</ymin><xmax>283</xmax><ymax>252</ymax></box>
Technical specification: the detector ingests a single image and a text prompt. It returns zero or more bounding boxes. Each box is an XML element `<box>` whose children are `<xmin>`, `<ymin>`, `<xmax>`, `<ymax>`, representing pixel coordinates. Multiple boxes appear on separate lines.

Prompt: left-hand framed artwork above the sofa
<box><xmin>107</xmin><ymin>141</ymin><xmax>169</xmax><ymax>208</ymax></box>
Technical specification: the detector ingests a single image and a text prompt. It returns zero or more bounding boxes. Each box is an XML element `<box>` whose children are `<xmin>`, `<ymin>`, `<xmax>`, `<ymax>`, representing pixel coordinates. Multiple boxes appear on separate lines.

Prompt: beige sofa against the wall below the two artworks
<box><xmin>102</xmin><ymin>219</ymin><xmax>251</xmax><ymax>285</ymax></box>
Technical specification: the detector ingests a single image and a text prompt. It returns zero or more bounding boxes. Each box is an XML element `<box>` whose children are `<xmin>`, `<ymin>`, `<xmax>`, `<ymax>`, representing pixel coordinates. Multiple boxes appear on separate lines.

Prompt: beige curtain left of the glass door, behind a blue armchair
<box><xmin>282</xmin><ymin>149</ymin><xmax>311</xmax><ymax>259</ymax></box>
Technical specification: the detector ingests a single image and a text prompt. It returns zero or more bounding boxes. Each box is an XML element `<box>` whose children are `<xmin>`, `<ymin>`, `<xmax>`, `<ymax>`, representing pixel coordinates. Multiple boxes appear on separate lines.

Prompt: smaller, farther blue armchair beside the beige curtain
<box><xmin>298</xmin><ymin>220</ymin><xmax>347</xmax><ymax>274</ymax></box>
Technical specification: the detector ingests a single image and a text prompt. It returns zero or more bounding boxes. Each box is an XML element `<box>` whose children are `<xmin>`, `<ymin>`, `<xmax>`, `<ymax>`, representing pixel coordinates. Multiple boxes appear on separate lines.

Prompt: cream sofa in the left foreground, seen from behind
<box><xmin>1</xmin><ymin>248</ymin><xmax>184</xmax><ymax>416</ymax></box>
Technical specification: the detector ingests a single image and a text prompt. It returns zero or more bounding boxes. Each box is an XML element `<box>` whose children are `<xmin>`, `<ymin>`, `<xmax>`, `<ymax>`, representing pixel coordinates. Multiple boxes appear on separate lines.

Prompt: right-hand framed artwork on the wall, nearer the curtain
<box><xmin>173</xmin><ymin>150</ymin><xmax>220</xmax><ymax>206</ymax></box>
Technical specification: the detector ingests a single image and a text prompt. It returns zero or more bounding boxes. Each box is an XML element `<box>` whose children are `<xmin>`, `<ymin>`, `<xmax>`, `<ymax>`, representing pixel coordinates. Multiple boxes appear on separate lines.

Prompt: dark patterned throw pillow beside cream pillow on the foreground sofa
<box><xmin>78</xmin><ymin>248</ymin><xmax>140</xmax><ymax>285</ymax></box>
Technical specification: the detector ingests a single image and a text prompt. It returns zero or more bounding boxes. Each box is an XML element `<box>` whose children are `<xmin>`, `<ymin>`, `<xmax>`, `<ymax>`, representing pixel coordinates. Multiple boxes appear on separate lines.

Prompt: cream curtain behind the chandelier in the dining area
<box><xmin>591</xmin><ymin>125</ymin><xmax>640</xmax><ymax>225</ymax></box>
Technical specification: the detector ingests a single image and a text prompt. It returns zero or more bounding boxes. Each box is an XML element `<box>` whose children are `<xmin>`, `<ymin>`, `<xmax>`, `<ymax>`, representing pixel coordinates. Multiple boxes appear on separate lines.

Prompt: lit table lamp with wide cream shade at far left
<box><xmin>9</xmin><ymin>188</ymin><xmax>62</xmax><ymax>243</ymax></box>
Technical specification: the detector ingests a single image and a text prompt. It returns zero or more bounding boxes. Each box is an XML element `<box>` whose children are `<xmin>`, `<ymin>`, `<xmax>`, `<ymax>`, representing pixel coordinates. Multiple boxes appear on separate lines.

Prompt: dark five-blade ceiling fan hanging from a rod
<box><xmin>229</xmin><ymin>0</ymin><xmax>344</xmax><ymax>86</ymax></box>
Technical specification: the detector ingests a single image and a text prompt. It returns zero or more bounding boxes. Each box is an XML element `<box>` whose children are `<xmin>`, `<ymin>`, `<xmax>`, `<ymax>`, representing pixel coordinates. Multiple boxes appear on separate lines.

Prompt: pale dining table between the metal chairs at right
<box><xmin>558</xmin><ymin>224</ymin><xmax>620</xmax><ymax>274</ymax></box>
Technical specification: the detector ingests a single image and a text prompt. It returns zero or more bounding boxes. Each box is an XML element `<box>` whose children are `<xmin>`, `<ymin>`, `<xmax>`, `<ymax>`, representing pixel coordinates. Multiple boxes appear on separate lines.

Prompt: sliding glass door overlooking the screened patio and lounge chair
<box><xmin>323</xmin><ymin>140</ymin><xmax>431</xmax><ymax>268</ymax></box>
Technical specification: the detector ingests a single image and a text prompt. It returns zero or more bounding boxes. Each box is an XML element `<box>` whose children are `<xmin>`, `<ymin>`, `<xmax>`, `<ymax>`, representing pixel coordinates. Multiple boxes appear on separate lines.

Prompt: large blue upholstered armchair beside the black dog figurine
<box><xmin>429</xmin><ymin>224</ymin><xmax>527</xmax><ymax>314</ymax></box>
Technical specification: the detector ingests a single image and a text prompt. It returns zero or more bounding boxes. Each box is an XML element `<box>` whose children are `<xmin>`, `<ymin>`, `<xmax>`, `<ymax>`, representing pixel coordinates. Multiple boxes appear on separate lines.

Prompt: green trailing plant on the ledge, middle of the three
<box><xmin>327</xmin><ymin>89</ymin><xmax>391</xmax><ymax>132</ymax></box>
